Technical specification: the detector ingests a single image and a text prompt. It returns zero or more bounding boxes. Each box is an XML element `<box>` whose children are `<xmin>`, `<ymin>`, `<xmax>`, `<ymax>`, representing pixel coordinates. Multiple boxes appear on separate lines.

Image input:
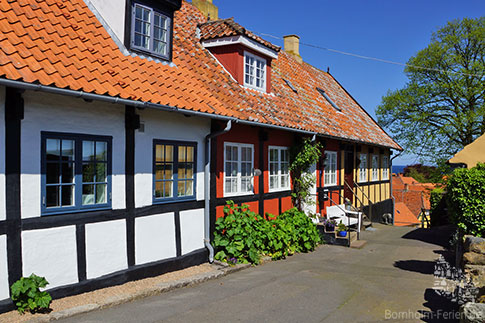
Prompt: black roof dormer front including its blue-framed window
<box><xmin>125</xmin><ymin>0</ymin><xmax>182</xmax><ymax>61</ymax></box>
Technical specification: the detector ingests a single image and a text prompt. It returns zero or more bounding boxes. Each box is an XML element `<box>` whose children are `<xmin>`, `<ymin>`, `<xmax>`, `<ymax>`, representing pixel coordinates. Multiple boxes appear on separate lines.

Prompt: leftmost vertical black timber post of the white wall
<box><xmin>5</xmin><ymin>87</ymin><xmax>24</xmax><ymax>292</ymax></box>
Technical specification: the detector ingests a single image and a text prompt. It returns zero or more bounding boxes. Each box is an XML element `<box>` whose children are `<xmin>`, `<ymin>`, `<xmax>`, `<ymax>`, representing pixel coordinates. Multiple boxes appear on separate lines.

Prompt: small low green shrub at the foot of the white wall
<box><xmin>10</xmin><ymin>274</ymin><xmax>52</xmax><ymax>314</ymax></box>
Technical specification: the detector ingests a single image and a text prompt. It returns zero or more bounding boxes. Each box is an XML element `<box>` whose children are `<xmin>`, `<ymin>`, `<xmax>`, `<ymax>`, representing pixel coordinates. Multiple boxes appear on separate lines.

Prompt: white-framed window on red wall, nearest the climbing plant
<box><xmin>268</xmin><ymin>146</ymin><xmax>290</xmax><ymax>192</ymax></box>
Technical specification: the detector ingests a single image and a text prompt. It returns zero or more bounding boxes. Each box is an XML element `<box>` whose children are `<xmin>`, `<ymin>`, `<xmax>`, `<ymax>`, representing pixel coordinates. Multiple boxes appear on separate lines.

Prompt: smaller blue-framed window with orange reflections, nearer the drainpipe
<box><xmin>153</xmin><ymin>140</ymin><xmax>197</xmax><ymax>203</ymax></box>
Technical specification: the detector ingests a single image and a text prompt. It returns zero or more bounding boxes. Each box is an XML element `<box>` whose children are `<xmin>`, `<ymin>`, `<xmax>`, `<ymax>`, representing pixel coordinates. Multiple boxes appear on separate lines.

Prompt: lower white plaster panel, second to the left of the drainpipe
<box><xmin>135</xmin><ymin>212</ymin><xmax>177</xmax><ymax>265</ymax></box>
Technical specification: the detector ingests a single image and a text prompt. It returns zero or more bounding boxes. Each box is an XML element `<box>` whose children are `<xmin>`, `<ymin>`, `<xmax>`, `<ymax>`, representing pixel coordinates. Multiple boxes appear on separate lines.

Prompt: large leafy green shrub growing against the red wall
<box><xmin>214</xmin><ymin>201</ymin><xmax>320</xmax><ymax>264</ymax></box>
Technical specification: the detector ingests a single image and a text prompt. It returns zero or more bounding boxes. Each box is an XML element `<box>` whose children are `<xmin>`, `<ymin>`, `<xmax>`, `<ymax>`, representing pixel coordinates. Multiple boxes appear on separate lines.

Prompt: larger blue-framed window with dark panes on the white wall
<box><xmin>41</xmin><ymin>132</ymin><xmax>112</xmax><ymax>215</ymax></box>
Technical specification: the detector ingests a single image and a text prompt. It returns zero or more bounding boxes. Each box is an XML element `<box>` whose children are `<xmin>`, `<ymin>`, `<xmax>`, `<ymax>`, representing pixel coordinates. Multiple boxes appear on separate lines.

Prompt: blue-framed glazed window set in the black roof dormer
<box><xmin>131</xmin><ymin>3</ymin><xmax>171</xmax><ymax>59</ymax></box>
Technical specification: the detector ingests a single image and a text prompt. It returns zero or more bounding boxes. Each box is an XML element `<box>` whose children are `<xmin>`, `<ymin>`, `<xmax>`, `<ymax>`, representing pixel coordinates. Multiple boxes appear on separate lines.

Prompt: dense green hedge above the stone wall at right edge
<box><xmin>447</xmin><ymin>163</ymin><xmax>485</xmax><ymax>237</ymax></box>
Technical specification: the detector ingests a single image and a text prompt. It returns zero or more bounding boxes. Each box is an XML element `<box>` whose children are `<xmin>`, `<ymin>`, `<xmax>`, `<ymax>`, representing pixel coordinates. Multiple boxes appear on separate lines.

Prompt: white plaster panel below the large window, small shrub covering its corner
<box><xmin>22</xmin><ymin>226</ymin><xmax>78</xmax><ymax>289</ymax></box>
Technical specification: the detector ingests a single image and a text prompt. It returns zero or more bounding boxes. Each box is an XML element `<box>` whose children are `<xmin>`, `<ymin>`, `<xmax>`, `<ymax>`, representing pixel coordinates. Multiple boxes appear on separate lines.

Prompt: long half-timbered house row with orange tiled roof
<box><xmin>0</xmin><ymin>0</ymin><xmax>401</xmax><ymax>310</ymax></box>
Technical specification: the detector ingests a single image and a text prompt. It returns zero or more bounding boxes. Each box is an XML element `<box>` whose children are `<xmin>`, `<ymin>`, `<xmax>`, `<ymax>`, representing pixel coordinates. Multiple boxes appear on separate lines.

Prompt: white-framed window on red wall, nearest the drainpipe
<box><xmin>224</xmin><ymin>142</ymin><xmax>254</xmax><ymax>196</ymax></box>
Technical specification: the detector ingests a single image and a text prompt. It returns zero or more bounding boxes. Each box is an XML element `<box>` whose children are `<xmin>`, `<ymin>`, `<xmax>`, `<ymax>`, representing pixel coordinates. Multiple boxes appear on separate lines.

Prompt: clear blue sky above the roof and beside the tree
<box><xmin>213</xmin><ymin>0</ymin><xmax>485</xmax><ymax>165</ymax></box>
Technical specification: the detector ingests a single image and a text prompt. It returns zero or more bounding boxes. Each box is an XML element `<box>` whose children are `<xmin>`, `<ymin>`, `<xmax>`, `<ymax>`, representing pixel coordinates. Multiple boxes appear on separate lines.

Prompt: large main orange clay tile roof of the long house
<box><xmin>0</xmin><ymin>0</ymin><xmax>401</xmax><ymax>149</ymax></box>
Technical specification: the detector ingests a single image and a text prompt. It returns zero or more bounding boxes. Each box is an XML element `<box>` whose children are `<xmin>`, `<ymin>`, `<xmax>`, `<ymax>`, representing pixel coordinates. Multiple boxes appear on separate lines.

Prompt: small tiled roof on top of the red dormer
<box><xmin>199</xmin><ymin>18</ymin><xmax>281</xmax><ymax>52</ymax></box>
